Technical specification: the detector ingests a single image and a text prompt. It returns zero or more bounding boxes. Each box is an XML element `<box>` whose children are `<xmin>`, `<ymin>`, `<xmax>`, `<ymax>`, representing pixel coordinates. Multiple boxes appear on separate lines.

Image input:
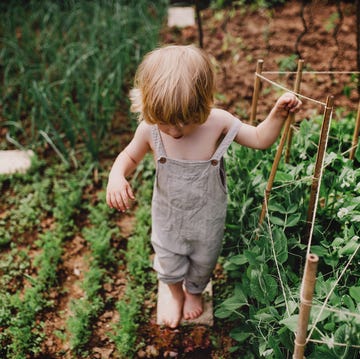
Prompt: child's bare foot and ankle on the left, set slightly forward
<box><xmin>161</xmin><ymin>283</ymin><xmax>184</xmax><ymax>328</ymax></box>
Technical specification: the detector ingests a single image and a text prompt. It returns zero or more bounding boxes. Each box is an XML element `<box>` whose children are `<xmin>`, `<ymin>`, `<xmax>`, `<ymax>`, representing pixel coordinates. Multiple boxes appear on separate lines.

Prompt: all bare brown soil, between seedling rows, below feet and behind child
<box><xmin>41</xmin><ymin>1</ymin><xmax>358</xmax><ymax>359</ymax></box>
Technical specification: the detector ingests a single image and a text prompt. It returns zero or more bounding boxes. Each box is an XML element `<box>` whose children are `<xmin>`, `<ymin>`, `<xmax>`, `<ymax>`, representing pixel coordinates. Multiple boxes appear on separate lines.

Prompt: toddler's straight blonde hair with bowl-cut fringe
<box><xmin>130</xmin><ymin>45</ymin><xmax>215</xmax><ymax>125</ymax></box>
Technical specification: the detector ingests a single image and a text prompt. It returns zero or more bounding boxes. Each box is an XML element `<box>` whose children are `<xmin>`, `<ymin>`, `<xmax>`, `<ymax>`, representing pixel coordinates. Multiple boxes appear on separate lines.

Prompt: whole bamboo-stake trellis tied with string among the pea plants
<box><xmin>246</xmin><ymin>60</ymin><xmax>360</xmax><ymax>359</ymax></box>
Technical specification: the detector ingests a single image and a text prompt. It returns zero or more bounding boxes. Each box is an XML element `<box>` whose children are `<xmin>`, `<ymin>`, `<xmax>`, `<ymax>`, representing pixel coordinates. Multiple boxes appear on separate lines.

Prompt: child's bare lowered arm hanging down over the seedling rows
<box><xmin>106</xmin><ymin>123</ymin><xmax>150</xmax><ymax>211</ymax></box>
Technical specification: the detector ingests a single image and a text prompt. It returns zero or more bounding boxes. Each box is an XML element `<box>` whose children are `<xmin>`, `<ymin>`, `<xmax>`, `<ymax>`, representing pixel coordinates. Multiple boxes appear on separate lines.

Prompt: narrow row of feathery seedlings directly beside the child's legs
<box><xmin>113</xmin><ymin>156</ymin><xmax>156</xmax><ymax>358</ymax></box>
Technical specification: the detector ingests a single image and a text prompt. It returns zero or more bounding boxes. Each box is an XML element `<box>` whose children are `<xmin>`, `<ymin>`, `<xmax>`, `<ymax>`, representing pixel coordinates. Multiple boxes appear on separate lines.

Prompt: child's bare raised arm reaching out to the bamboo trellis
<box><xmin>235</xmin><ymin>92</ymin><xmax>302</xmax><ymax>149</ymax></box>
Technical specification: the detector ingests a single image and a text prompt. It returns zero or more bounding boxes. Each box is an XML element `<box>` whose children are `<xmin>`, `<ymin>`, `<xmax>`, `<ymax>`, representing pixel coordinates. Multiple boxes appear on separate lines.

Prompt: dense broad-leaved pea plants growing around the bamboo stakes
<box><xmin>216</xmin><ymin>114</ymin><xmax>360</xmax><ymax>358</ymax></box>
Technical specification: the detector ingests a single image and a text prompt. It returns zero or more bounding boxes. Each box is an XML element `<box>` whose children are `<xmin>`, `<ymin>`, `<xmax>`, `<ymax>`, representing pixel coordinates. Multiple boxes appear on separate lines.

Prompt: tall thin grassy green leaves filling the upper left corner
<box><xmin>0</xmin><ymin>0</ymin><xmax>166</xmax><ymax>163</ymax></box>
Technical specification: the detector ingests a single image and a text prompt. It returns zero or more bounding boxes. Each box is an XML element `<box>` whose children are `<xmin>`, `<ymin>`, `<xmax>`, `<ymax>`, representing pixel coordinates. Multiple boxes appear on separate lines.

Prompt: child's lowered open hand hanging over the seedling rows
<box><xmin>106</xmin><ymin>178</ymin><xmax>135</xmax><ymax>212</ymax></box>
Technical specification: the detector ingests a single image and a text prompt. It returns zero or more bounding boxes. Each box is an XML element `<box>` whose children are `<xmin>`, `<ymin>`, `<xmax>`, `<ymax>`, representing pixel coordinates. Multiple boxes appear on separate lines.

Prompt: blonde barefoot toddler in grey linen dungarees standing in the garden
<box><xmin>106</xmin><ymin>45</ymin><xmax>301</xmax><ymax>328</ymax></box>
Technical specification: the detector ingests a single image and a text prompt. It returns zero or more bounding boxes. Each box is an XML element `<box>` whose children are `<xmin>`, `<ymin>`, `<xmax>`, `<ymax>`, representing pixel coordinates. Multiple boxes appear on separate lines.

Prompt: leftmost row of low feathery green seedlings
<box><xmin>0</xmin><ymin>162</ymin><xmax>87</xmax><ymax>359</ymax></box>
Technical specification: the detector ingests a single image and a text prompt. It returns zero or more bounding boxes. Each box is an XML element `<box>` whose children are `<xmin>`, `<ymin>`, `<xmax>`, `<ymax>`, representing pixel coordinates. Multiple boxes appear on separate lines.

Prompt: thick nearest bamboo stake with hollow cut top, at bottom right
<box><xmin>293</xmin><ymin>254</ymin><xmax>319</xmax><ymax>359</ymax></box>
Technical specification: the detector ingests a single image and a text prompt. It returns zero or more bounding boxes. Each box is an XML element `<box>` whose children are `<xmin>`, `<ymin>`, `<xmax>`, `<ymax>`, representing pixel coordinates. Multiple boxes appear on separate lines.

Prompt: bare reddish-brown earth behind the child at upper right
<box><xmin>164</xmin><ymin>0</ymin><xmax>358</xmax><ymax>120</ymax></box>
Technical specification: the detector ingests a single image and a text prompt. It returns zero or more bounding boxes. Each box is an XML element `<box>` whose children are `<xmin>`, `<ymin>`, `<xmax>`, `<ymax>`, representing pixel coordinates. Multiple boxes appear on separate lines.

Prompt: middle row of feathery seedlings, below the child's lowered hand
<box><xmin>67</xmin><ymin>191</ymin><xmax>119</xmax><ymax>357</ymax></box>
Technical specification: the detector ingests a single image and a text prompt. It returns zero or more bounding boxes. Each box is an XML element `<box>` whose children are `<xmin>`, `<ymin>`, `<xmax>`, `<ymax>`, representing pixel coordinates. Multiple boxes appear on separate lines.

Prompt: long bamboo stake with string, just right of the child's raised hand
<box><xmin>302</xmin><ymin>96</ymin><xmax>334</xmax><ymax>244</ymax></box>
